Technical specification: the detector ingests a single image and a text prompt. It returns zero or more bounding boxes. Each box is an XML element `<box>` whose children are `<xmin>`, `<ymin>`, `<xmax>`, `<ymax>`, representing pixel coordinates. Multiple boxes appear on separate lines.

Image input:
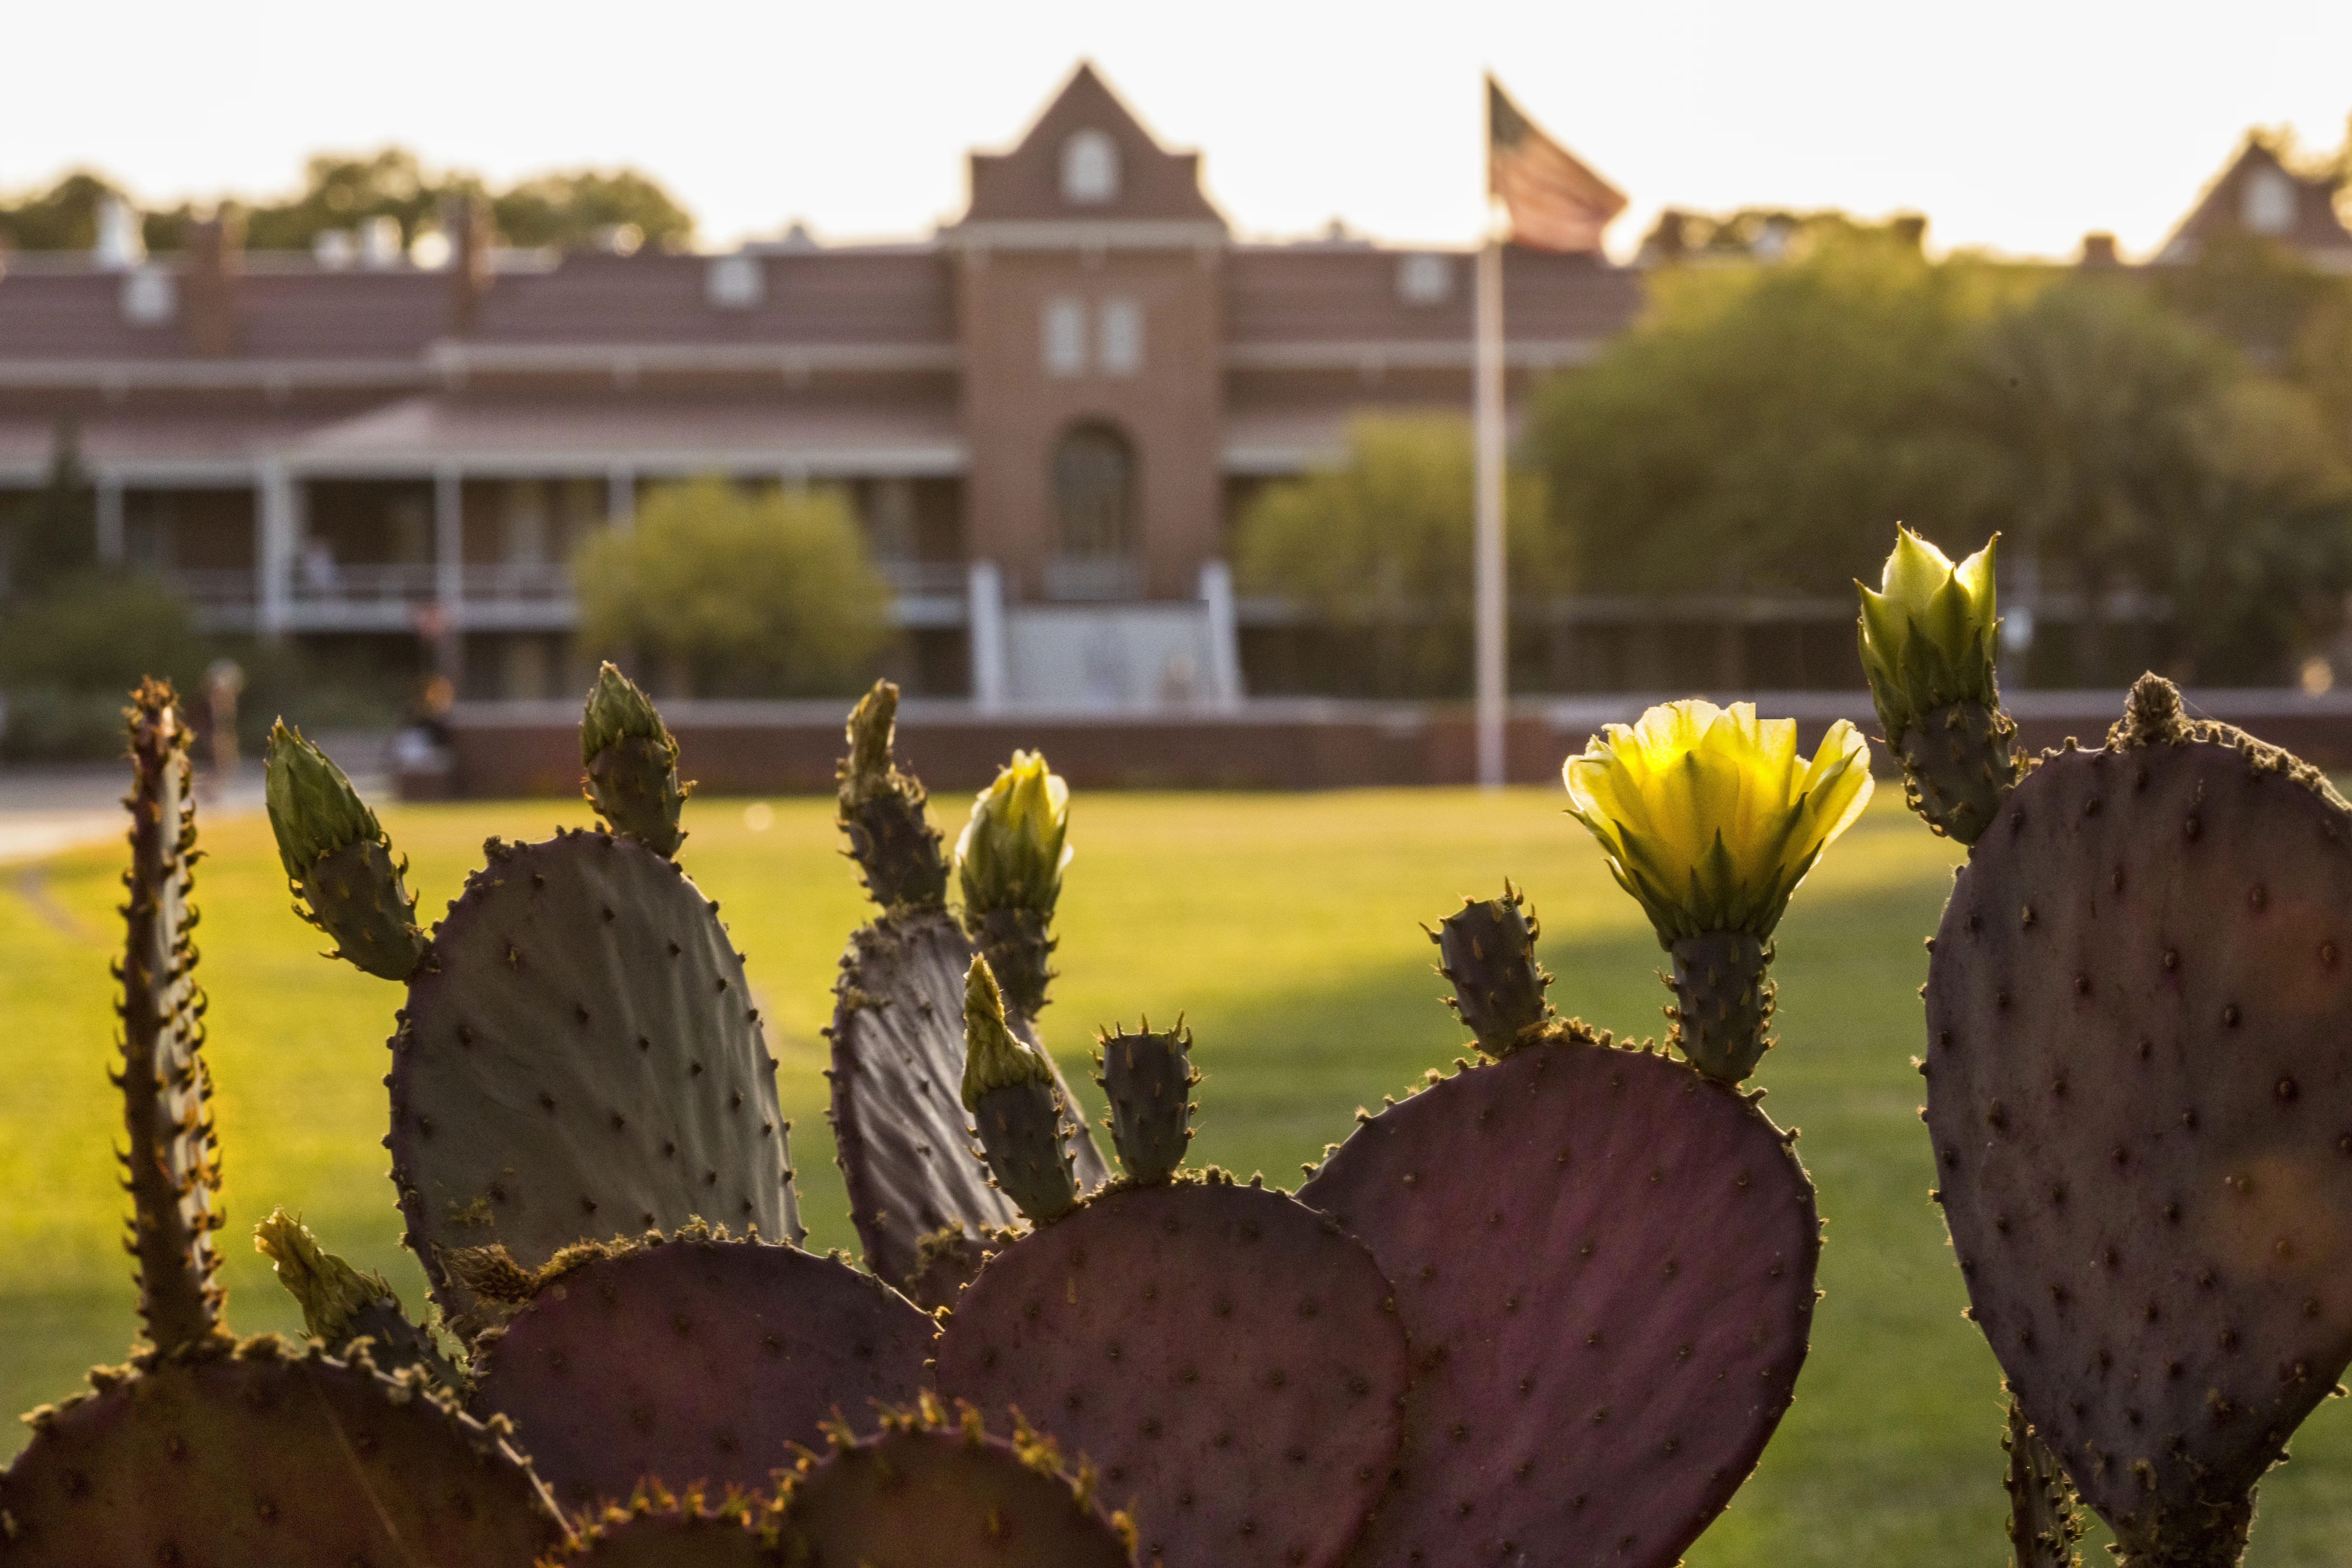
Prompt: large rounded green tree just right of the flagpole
<box><xmin>1527</xmin><ymin>226</ymin><xmax>2018</xmax><ymax>595</ymax></box>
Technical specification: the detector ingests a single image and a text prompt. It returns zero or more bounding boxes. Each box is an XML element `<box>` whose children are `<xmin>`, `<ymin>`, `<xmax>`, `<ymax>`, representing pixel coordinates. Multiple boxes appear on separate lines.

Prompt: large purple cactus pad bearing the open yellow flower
<box><xmin>1308</xmin><ymin>1025</ymin><xmax>1821</xmax><ymax>1568</ymax></box>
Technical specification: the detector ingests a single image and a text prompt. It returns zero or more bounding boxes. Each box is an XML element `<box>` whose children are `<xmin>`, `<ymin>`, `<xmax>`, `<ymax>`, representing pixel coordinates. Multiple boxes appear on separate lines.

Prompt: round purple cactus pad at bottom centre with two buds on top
<box><xmin>938</xmin><ymin>1175</ymin><xmax>1411</xmax><ymax>1568</ymax></box>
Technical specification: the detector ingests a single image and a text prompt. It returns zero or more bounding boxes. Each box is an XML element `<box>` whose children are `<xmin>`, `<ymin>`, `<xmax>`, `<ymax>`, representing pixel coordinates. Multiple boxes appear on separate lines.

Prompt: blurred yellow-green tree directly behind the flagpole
<box><xmin>1235</xmin><ymin>414</ymin><xmax>1559</xmax><ymax>696</ymax></box>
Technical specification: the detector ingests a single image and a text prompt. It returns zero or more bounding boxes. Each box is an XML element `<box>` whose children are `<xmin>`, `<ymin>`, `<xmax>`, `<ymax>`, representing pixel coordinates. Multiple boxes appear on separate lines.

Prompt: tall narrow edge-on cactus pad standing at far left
<box><xmin>120</xmin><ymin>679</ymin><xmax>221</xmax><ymax>1354</ymax></box>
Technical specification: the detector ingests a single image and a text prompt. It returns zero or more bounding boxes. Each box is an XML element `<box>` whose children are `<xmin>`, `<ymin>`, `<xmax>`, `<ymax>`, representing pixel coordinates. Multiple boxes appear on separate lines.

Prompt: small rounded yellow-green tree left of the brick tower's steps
<box><xmin>574</xmin><ymin>480</ymin><xmax>889</xmax><ymax>696</ymax></box>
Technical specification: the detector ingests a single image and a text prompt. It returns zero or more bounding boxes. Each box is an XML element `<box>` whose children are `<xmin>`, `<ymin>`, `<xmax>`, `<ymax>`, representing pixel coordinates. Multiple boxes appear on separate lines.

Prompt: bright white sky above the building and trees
<box><xmin>0</xmin><ymin>0</ymin><xmax>2352</xmax><ymax>256</ymax></box>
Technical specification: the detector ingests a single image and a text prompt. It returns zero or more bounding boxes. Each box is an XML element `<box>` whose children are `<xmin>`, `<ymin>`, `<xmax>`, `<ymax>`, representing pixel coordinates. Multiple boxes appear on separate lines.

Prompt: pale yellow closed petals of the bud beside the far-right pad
<box><xmin>1856</xmin><ymin>529</ymin><xmax>2001</xmax><ymax>750</ymax></box>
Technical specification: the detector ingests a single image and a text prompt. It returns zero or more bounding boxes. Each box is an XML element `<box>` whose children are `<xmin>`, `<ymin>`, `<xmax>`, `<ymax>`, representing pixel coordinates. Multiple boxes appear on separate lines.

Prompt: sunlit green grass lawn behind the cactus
<box><xmin>0</xmin><ymin>790</ymin><xmax>2352</xmax><ymax>1568</ymax></box>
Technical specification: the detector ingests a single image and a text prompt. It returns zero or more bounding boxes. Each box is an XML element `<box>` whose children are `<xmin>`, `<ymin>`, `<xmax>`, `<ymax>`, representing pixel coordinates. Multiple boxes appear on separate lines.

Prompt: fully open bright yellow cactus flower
<box><xmin>1562</xmin><ymin>698</ymin><xmax>1870</xmax><ymax>948</ymax></box>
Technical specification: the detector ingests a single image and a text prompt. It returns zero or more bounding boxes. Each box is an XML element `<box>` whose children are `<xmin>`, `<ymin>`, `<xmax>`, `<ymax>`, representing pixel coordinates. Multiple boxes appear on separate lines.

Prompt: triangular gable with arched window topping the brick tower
<box><xmin>946</xmin><ymin>64</ymin><xmax>1225</xmax><ymax>247</ymax></box>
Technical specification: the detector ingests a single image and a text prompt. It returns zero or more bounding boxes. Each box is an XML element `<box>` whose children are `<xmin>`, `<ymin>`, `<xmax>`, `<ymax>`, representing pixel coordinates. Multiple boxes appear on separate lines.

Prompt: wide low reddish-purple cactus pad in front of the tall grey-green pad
<box><xmin>473</xmin><ymin>1232</ymin><xmax>932</xmax><ymax>1507</ymax></box>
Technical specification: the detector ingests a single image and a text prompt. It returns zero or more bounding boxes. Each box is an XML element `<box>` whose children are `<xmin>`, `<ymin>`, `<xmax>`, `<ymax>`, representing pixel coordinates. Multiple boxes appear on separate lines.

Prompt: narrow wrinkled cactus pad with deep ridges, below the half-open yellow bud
<box><xmin>830</xmin><ymin>910</ymin><xmax>1110</xmax><ymax>1288</ymax></box>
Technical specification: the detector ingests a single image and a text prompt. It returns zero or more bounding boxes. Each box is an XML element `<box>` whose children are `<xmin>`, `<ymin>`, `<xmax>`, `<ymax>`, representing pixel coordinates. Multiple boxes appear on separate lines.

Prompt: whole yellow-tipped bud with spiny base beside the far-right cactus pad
<box><xmin>1856</xmin><ymin>529</ymin><xmax>2021</xmax><ymax>844</ymax></box>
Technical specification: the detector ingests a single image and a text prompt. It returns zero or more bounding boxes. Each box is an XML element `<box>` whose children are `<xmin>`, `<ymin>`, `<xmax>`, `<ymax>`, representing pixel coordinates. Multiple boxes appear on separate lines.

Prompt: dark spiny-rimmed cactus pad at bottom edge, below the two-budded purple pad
<box><xmin>783</xmin><ymin>1399</ymin><xmax>1134</xmax><ymax>1568</ymax></box>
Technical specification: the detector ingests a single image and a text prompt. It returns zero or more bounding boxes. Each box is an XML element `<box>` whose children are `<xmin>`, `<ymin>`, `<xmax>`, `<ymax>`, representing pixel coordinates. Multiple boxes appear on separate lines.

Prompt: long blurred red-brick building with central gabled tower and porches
<box><xmin>0</xmin><ymin>66</ymin><xmax>1639</xmax><ymax>703</ymax></box>
